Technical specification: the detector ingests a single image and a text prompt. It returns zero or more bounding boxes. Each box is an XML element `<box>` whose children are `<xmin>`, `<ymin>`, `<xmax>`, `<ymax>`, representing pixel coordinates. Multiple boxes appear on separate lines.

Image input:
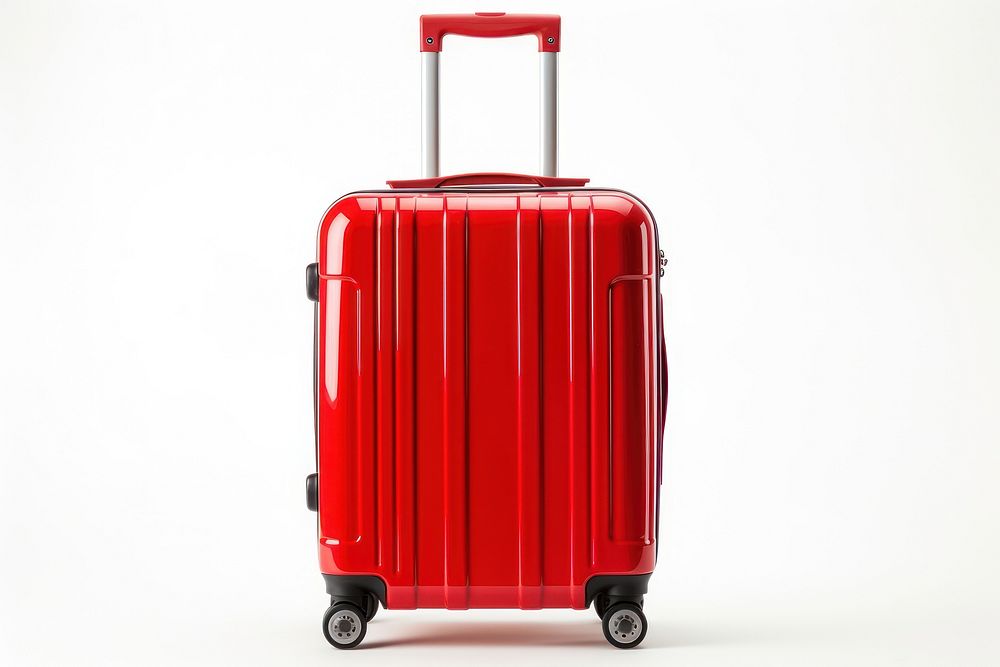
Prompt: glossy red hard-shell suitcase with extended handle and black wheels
<box><xmin>307</xmin><ymin>14</ymin><xmax>666</xmax><ymax>648</ymax></box>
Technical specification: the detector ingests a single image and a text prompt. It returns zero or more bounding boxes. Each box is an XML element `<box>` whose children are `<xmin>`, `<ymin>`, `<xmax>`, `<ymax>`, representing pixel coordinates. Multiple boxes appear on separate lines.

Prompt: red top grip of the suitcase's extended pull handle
<box><xmin>420</xmin><ymin>12</ymin><xmax>560</xmax><ymax>51</ymax></box>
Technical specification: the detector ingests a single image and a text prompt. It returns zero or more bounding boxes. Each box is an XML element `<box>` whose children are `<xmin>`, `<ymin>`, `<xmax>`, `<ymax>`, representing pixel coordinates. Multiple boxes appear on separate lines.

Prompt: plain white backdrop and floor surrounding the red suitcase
<box><xmin>0</xmin><ymin>0</ymin><xmax>1000</xmax><ymax>667</ymax></box>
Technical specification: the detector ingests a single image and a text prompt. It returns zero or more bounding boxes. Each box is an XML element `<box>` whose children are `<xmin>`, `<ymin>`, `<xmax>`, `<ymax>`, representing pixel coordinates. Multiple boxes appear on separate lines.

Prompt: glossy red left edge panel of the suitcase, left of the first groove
<box><xmin>317</xmin><ymin>199</ymin><xmax>381</xmax><ymax>571</ymax></box>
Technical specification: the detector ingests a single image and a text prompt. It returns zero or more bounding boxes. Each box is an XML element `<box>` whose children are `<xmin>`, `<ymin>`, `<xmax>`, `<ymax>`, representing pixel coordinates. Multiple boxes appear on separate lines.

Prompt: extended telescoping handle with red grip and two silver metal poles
<box><xmin>420</xmin><ymin>12</ymin><xmax>560</xmax><ymax>178</ymax></box>
